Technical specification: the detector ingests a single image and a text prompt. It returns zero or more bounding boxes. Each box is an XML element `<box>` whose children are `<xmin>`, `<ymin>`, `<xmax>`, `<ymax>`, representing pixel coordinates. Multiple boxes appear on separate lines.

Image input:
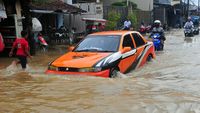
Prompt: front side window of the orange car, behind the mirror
<box><xmin>122</xmin><ymin>34</ymin><xmax>134</xmax><ymax>49</ymax></box>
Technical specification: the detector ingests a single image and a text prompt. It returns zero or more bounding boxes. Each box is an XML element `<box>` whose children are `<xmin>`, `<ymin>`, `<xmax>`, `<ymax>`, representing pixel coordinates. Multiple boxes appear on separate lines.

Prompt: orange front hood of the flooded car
<box><xmin>52</xmin><ymin>52</ymin><xmax>112</xmax><ymax>68</ymax></box>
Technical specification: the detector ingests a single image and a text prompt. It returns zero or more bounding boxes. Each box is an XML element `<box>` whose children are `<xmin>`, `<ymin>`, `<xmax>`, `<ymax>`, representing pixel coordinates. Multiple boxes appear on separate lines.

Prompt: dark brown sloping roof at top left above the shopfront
<box><xmin>30</xmin><ymin>0</ymin><xmax>86</xmax><ymax>13</ymax></box>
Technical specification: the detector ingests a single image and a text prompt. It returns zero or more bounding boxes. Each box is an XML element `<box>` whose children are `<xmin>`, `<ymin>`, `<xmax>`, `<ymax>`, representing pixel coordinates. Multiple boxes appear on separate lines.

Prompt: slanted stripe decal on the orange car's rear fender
<box><xmin>136</xmin><ymin>43</ymin><xmax>153</xmax><ymax>68</ymax></box>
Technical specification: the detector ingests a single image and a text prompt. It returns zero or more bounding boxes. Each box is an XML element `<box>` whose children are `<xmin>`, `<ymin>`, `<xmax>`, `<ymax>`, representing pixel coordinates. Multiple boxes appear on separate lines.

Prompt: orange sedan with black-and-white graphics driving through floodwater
<box><xmin>46</xmin><ymin>31</ymin><xmax>155</xmax><ymax>78</ymax></box>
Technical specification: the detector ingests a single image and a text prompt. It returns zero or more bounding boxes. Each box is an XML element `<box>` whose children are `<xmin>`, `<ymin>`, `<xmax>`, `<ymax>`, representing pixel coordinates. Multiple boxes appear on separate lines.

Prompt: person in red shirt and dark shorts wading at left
<box><xmin>9</xmin><ymin>31</ymin><xmax>32</xmax><ymax>69</ymax></box>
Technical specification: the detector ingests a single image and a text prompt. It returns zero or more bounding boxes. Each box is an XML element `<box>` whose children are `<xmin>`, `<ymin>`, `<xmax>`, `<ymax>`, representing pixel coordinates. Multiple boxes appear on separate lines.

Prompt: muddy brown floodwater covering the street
<box><xmin>0</xmin><ymin>30</ymin><xmax>200</xmax><ymax>113</ymax></box>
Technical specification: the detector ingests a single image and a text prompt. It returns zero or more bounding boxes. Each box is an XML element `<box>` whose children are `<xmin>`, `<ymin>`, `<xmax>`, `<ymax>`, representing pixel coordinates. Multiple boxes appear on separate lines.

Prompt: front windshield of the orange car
<box><xmin>74</xmin><ymin>35</ymin><xmax>121</xmax><ymax>52</ymax></box>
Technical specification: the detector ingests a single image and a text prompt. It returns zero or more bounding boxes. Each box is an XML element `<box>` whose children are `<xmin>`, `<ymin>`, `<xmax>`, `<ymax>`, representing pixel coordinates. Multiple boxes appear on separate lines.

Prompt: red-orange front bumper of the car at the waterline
<box><xmin>45</xmin><ymin>69</ymin><xmax>110</xmax><ymax>78</ymax></box>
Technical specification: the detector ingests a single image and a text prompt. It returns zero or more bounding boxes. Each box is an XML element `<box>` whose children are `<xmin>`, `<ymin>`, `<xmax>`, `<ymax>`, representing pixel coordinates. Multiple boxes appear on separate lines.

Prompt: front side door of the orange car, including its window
<box><xmin>119</xmin><ymin>34</ymin><xmax>136</xmax><ymax>73</ymax></box>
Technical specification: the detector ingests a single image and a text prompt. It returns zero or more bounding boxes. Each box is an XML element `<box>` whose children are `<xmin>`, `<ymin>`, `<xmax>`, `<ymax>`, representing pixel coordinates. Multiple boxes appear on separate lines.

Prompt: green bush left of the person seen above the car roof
<box><xmin>105</xmin><ymin>11</ymin><xmax>121</xmax><ymax>30</ymax></box>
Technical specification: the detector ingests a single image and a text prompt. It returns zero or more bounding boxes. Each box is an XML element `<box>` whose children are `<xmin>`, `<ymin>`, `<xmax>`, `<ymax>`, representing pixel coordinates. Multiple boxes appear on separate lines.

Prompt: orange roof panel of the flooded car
<box><xmin>90</xmin><ymin>30</ymin><xmax>138</xmax><ymax>35</ymax></box>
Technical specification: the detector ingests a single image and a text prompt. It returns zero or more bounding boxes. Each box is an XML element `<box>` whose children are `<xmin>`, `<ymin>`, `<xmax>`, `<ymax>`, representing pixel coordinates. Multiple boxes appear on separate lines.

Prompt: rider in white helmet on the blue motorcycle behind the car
<box><xmin>151</xmin><ymin>20</ymin><xmax>166</xmax><ymax>49</ymax></box>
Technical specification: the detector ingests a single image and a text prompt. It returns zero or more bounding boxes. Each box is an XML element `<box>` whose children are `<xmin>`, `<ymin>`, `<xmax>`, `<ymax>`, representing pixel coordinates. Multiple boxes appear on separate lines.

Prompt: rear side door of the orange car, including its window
<box><xmin>132</xmin><ymin>33</ymin><xmax>146</xmax><ymax>68</ymax></box>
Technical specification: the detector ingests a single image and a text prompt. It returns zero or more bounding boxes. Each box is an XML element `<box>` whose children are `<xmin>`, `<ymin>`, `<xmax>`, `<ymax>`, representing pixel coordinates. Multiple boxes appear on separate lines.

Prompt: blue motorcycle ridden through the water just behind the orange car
<box><xmin>150</xmin><ymin>33</ymin><xmax>164</xmax><ymax>51</ymax></box>
